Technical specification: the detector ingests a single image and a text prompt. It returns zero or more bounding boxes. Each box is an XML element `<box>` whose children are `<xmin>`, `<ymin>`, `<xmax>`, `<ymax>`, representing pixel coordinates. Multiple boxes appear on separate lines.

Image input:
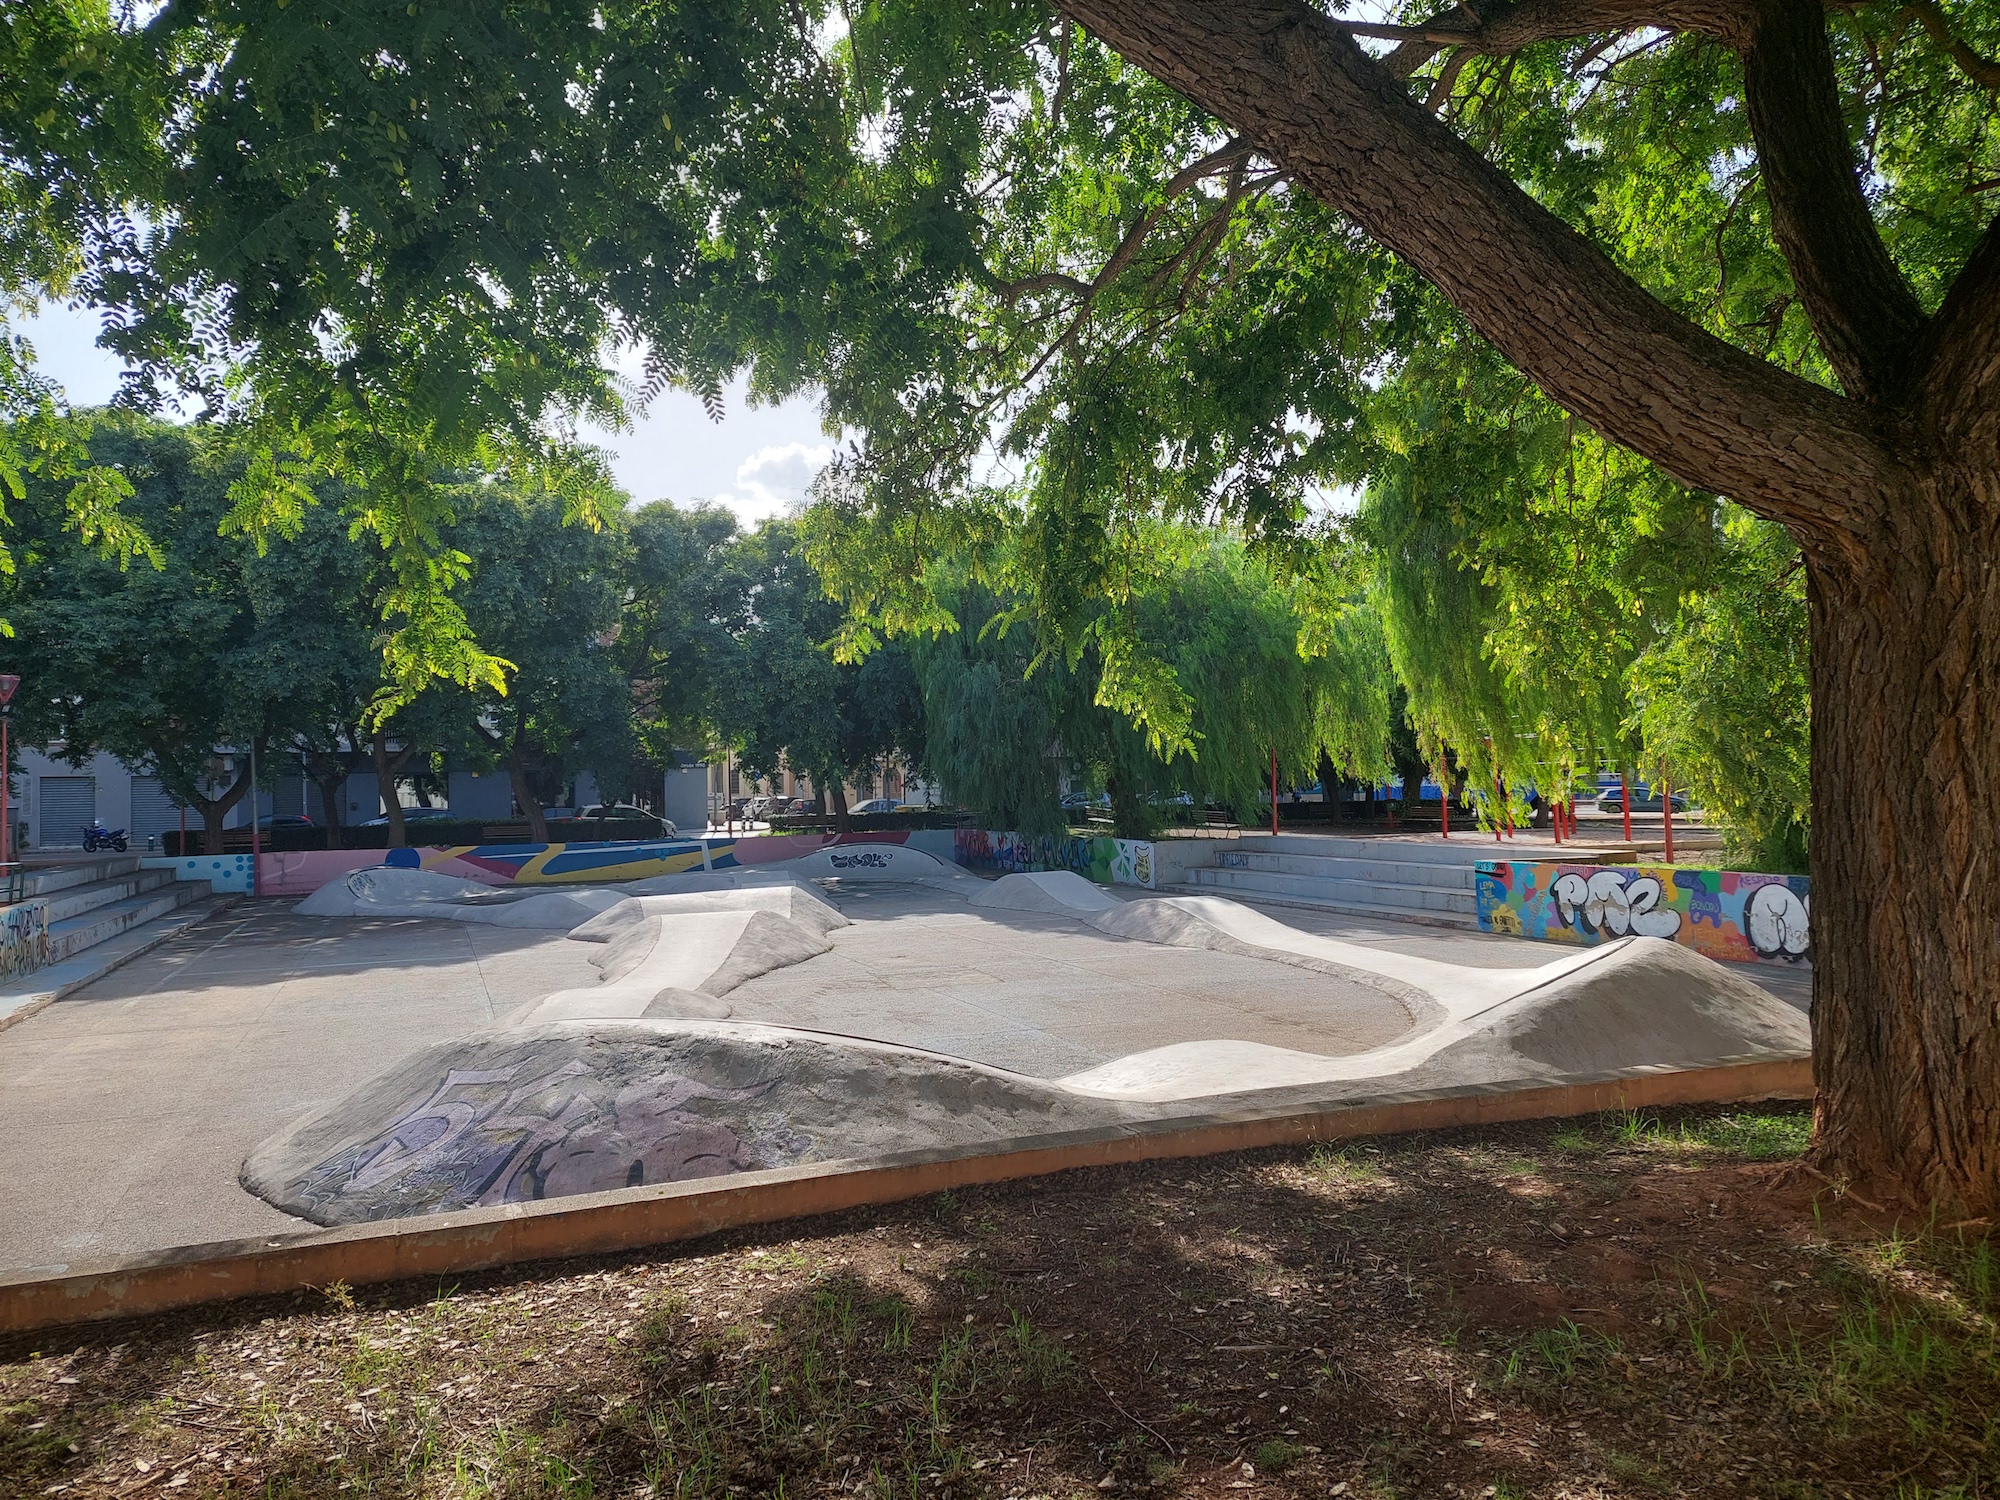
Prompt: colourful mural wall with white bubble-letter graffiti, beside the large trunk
<box><xmin>1474</xmin><ymin>860</ymin><xmax>1812</xmax><ymax>964</ymax></box>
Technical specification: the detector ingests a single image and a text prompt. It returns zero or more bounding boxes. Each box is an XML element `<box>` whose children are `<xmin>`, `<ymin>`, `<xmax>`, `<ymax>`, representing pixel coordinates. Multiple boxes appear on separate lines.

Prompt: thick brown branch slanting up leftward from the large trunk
<box><xmin>1064</xmin><ymin>0</ymin><xmax>1904</xmax><ymax>564</ymax></box>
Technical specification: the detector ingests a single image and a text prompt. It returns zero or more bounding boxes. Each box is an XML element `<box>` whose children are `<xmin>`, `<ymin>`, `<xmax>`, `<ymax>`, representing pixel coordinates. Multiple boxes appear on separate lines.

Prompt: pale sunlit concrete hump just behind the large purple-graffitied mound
<box><xmin>516</xmin><ymin>908</ymin><xmax>832</xmax><ymax>1026</ymax></box>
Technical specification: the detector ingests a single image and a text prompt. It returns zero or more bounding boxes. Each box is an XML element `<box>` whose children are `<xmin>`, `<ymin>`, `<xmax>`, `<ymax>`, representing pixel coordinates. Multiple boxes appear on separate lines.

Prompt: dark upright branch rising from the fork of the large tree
<box><xmin>1742</xmin><ymin>0</ymin><xmax>1924</xmax><ymax>400</ymax></box>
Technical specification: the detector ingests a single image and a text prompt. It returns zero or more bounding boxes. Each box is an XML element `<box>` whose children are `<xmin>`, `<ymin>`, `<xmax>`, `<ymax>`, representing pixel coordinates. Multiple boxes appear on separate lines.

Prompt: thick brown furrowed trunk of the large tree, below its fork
<box><xmin>1812</xmin><ymin>470</ymin><xmax>2000</xmax><ymax>1216</ymax></box>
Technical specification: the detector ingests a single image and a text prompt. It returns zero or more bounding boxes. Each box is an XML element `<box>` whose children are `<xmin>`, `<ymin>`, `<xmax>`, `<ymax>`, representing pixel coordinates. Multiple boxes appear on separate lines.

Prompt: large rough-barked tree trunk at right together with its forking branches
<box><xmin>1066</xmin><ymin>0</ymin><xmax>2000</xmax><ymax>1214</ymax></box>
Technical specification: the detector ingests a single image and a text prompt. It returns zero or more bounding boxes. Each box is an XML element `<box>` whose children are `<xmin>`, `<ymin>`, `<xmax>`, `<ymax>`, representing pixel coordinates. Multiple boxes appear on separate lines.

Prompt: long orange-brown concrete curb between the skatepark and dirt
<box><xmin>0</xmin><ymin>1058</ymin><xmax>1812</xmax><ymax>1334</ymax></box>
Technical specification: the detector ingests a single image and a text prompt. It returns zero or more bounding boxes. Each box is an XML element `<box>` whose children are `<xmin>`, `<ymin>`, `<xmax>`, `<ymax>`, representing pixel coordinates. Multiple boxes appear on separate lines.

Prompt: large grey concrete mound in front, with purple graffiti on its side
<box><xmin>242</xmin><ymin>1020</ymin><xmax>1132</xmax><ymax>1224</ymax></box>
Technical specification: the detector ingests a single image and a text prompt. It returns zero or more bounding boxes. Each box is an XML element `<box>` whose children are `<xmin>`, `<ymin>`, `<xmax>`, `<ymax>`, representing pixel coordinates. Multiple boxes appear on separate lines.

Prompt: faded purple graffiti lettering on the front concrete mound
<box><xmin>290</xmin><ymin>1058</ymin><xmax>810</xmax><ymax>1218</ymax></box>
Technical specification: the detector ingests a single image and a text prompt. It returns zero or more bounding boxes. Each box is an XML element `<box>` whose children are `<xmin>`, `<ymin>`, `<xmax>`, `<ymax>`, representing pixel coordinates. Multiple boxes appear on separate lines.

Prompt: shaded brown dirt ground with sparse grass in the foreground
<box><xmin>0</xmin><ymin>1110</ymin><xmax>2000</xmax><ymax>1500</ymax></box>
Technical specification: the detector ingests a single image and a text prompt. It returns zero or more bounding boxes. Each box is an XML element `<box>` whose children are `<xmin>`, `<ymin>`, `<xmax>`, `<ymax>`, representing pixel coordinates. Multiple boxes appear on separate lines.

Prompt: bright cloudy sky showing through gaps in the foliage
<box><xmin>14</xmin><ymin>306</ymin><xmax>834</xmax><ymax>526</ymax></box>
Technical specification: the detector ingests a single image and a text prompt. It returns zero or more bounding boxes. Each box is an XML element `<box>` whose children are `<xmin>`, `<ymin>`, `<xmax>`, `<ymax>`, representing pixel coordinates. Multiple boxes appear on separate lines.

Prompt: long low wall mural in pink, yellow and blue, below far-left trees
<box><xmin>252</xmin><ymin>832</ymin><xmax>928</xmax><ymax>896</ymax></box>
